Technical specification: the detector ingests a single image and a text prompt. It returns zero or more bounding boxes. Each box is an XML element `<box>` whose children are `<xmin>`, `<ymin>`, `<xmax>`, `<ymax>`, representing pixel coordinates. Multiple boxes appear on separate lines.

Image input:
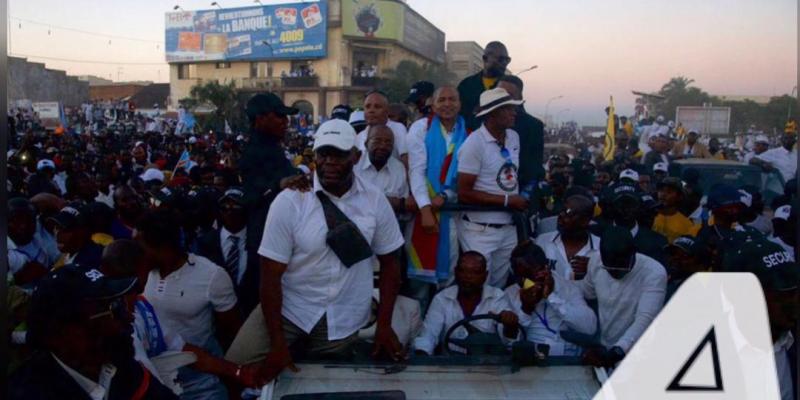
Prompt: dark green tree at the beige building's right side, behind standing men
<box><xmin>381</xmin><ymin>60</ymin><xmax>455</xmax><ymax>103</ymax></box>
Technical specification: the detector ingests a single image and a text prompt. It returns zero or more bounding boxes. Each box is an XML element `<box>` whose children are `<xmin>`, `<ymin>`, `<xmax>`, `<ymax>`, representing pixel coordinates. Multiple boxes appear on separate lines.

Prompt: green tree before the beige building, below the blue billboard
<box><xmin>178</xmin><ymin>80</ymin><xmax>242</xmax><ymax>132</ymax></box>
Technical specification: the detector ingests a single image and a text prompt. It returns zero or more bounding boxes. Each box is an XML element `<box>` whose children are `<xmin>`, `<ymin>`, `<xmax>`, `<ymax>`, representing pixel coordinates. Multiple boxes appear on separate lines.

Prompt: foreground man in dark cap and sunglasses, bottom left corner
<box><xmin>8</xmin><ymin>265</ymin><xmax>177</xmax><ymax>400</ymax></box>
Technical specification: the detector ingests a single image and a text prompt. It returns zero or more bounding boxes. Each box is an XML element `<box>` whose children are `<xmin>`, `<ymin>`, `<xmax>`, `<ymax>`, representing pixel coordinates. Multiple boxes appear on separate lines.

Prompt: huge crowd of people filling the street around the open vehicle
<box><xmin>7</xmin><ymin>38</ymin><xmax>800</xmax><ymax>400</ymax></box>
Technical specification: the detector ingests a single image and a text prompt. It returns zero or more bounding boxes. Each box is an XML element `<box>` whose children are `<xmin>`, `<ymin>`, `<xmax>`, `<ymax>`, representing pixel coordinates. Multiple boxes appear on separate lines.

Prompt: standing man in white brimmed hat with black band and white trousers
<box><xmin>458</xmin><ymin>88</ymin><xmax>528</xmax><ymax>287</ymax></box>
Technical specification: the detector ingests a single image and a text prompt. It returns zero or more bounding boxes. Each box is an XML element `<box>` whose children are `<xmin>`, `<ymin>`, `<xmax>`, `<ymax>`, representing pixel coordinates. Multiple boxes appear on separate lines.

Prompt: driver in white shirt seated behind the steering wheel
<box><xmin>414</xmin><ymin>251</ymin><xmax>519</xmax><ymax>355</ymax></box>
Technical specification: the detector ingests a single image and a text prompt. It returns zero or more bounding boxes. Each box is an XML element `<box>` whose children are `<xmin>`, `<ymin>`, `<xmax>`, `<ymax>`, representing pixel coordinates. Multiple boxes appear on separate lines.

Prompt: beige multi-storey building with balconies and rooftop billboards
<box><xmin>165</xmin><ymin>0</ymin><xmax>445</xmax><ymax>120</ymax></box>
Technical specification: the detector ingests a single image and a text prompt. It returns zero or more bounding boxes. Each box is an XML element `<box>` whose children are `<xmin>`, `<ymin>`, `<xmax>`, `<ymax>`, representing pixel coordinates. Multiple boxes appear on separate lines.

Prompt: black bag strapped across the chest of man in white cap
<box><xmin>317</xmin><ymin>191</ymin><xmax>373</xmax><ymax>268</ymax></box>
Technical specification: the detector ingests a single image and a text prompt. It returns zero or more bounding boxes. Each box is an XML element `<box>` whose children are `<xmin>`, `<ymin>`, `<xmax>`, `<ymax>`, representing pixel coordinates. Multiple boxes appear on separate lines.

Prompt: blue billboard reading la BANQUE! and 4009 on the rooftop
<box><xmin>164</xmin><ymin>1</ymin><xmax>328</xmax><ymax>62</ymax></box>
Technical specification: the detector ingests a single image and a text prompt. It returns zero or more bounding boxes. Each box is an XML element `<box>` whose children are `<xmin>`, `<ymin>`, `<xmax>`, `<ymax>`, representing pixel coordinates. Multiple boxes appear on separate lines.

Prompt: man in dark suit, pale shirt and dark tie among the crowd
<box><xmin>197</xmin><ymin>188</ymin><xmax>259</xmax><ymax>317</ymax></box>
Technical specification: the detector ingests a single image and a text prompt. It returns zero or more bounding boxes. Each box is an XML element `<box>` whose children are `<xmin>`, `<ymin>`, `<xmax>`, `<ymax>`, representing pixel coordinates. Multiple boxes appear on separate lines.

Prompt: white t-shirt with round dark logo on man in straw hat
<box><xmin>458</xmin><ymin>125</ymin><xmax>520</xmax><ymax>224</ymax></box>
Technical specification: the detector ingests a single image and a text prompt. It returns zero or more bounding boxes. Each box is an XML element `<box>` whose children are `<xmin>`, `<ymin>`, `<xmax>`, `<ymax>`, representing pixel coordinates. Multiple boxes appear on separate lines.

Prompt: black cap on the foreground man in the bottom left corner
<box><xmin>28</xmin><ymin>265</ymin><xmax>136</xmax><ymax>344</ymax></box>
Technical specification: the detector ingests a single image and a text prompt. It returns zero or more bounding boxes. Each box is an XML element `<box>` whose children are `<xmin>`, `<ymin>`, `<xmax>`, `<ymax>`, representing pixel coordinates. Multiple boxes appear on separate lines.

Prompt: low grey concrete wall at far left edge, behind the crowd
<box><xmin>8</xmin><ymin>57</ymin><xmax>89</xmax><ymax>106</ymax></box>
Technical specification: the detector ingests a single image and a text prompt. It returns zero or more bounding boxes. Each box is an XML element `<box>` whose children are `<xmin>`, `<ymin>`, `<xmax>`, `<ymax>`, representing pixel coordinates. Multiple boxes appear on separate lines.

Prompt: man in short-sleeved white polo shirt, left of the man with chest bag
<box><xmin>136</xmin><ymin>210</ymin><xmax>241</xmax><ymax>399</ymax></box>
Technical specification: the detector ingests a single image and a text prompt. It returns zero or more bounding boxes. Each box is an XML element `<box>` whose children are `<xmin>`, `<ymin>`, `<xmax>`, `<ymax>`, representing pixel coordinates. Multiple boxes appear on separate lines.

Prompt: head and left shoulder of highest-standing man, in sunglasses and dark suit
<box><xmin>458</xmin><ymin>42</ymin><xmax>511</xmax><ymax>131</ymax></box>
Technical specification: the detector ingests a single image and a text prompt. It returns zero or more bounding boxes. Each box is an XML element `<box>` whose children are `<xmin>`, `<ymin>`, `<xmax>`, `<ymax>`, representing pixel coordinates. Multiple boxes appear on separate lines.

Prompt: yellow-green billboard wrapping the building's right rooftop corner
<box><xmin>342</xmin><ymin>0</ymin><xmax>445</xmax><ymax>63</ymax></box>
